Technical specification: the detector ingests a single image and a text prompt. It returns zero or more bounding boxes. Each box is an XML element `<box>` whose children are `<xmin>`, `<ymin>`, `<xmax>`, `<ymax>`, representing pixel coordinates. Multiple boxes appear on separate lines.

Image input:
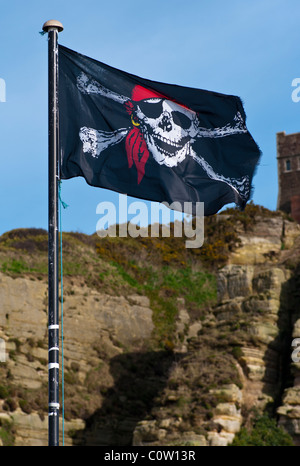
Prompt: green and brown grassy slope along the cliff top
<box><xmin>0</xmin><ymin>203</ymin><xmax>286</xmax><ymax>347</ymax></box>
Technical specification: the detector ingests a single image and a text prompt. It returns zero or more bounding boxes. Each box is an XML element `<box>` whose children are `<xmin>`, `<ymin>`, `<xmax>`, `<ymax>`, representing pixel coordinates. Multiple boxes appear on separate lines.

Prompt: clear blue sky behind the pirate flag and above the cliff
<box><xmin>0</xmin><ymin>0</ymin><xmax>300</xmax><ymax>234</ymax></box>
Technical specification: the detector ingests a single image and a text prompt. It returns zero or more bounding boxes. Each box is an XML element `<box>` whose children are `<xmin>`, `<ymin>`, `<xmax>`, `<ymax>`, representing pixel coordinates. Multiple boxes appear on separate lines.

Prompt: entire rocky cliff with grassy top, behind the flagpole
<box><xmin>0</xmin><ymin>206</ymin><xmax>300</xmax><ymax>446</ymax></box>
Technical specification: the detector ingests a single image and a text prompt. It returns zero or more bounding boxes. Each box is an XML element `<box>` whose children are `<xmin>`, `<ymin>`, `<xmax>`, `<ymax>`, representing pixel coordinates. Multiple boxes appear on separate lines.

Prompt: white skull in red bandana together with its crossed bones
<box><xmin>77</xmin><ymin>73</ymin><xmax>250</xmax><ymax>199</ymax></box>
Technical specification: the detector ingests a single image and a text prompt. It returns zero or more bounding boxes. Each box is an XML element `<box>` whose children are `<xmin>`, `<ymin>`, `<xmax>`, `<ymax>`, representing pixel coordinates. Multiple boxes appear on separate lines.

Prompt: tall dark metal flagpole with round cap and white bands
<box><xmin>43</xmin><ymin>20</ymin><xmax>63</xmax><ymax>446</ymax></box>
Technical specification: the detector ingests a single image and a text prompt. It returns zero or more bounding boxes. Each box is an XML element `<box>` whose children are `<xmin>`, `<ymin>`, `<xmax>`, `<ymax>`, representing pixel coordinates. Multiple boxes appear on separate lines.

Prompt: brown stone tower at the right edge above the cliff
<box><xmin>276</xmin><ymin>131</ymin><xmax>300</xmax><ymax>223</ymax></box>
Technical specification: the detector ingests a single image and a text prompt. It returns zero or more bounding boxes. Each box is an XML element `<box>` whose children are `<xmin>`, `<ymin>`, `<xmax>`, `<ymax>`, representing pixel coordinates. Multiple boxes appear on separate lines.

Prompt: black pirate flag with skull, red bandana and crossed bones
<box><xmin>59</xmin><ymin>46</ymin><xmax>260</xmax><ymax>215</ymax></box>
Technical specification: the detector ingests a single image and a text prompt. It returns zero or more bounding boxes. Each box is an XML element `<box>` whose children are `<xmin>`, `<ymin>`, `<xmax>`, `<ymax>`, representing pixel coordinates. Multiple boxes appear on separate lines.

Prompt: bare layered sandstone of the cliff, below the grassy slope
<box><xmin>0</xmin><ymin>213</ymin><xmax>300</xmax><ymax>446</ymax></box>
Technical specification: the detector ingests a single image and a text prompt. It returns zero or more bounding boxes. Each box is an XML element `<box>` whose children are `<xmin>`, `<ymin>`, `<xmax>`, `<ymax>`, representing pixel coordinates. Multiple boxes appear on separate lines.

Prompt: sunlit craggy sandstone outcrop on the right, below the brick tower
<box><xmin>133</xmin><ymin>218</ymin><xmax>300</xmax><ymax>446</ymax></box>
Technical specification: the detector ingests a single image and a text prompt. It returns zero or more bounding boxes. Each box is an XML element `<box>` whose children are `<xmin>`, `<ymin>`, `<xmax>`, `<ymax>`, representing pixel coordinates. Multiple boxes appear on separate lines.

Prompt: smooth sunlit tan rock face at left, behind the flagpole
<box><xmin>0</xmin><ymin>273</ymin><xmax>153</xmax><ymax>445</ymax></box>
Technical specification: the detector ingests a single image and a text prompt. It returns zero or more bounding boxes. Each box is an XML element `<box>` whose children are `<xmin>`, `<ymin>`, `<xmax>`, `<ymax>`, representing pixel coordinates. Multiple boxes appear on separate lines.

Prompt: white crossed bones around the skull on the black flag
<box><xmin>77</xmin><ymin>72</ymin><xmax>250</xmax><ymax>202</ymax></box>
